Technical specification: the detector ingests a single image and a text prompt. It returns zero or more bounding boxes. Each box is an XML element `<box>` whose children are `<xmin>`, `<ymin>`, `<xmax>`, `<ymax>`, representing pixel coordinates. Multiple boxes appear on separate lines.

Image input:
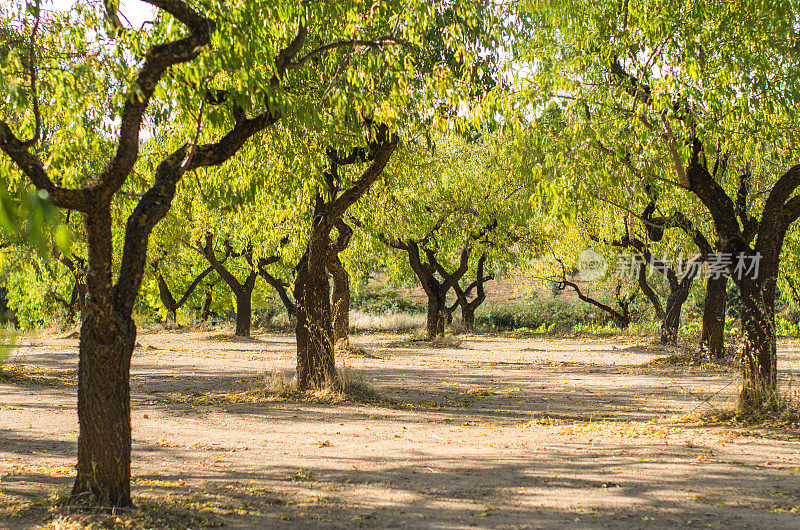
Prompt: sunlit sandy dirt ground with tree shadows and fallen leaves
<box><xmin>0</xmin><ymin>332</ymin><xmax>800</xmax><ymax>529</ymax></box>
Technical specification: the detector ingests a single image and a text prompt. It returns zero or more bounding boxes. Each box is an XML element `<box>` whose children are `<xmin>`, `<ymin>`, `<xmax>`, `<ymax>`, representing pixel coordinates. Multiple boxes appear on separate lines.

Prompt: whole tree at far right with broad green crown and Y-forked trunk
<box><xmin>528</xmin><ymin>0</ymin><xmax>800</xmax><ymax>411</ymax></box>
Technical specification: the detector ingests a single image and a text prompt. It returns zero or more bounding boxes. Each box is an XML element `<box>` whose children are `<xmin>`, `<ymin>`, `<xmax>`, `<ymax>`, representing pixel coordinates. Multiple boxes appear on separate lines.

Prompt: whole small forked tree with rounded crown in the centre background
<box><xmin>358</xmin><ymin>135</ymin><xmax>530</xmax><ymax>339</ymax></box>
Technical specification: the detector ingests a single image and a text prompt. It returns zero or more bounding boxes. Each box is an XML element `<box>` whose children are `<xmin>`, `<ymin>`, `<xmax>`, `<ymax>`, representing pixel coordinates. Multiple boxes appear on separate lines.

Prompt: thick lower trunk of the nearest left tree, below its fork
<box><xmin>72</xmin><ymin>312</ymin><xmax>136</xmax><ymax>507</ymax></box>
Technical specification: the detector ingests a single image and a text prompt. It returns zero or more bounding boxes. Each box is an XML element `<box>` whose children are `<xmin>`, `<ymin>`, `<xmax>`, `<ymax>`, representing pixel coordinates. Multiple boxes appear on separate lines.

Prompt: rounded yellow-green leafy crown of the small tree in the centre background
<box><xmin>353</xmin><ymin>131</ymin><xmax>536</xmax><ymax>285</ymax></box>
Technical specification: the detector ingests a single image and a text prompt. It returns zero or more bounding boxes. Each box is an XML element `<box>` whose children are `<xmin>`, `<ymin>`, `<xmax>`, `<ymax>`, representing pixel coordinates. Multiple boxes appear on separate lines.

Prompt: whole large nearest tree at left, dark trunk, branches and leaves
<box><xmin>0</xmin><ymin>0</ymin><xmax>410</xmax><ymax>506</ymax></box>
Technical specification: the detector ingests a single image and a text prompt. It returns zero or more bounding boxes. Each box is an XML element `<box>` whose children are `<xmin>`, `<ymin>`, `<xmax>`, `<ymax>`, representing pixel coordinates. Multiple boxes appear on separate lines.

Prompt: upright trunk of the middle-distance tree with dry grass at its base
<box><xmin>294</xmin><ymin>246</ymin><xmax>340</xmax><ymax>390</ymax></box>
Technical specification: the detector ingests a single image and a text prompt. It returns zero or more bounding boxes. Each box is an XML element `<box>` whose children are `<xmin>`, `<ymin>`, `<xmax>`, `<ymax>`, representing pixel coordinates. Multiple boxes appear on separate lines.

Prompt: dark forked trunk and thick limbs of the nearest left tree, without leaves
<box><xmin>0</xmin><ymin>1</ymin><xmax>307</xmax><ymax>507</ymax></box>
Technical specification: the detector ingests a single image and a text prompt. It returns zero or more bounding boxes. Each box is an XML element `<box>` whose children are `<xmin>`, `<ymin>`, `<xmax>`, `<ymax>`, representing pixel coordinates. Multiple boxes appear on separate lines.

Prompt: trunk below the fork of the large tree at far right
<box><xmin>739</xmin><ymin>278</ymin><xmax>778</xmax><ymax>411</ymax></box>
